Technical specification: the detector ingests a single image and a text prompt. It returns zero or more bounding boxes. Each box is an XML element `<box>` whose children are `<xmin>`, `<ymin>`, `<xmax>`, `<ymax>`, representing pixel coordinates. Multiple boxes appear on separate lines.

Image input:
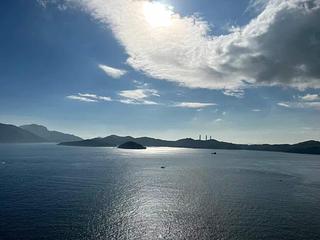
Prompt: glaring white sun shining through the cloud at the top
<box><xmin>143</xmin><ymin>2</ymin><xmax>173</xmax><ymax>27</ymax></box>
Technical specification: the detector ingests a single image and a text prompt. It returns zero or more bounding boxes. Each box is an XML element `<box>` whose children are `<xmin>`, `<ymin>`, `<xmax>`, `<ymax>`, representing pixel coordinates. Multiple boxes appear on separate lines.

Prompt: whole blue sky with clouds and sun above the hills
<box><xmin>0</xmin><ymin>0</ymin><xmax>320</xmax><ymax>143</ymax></box>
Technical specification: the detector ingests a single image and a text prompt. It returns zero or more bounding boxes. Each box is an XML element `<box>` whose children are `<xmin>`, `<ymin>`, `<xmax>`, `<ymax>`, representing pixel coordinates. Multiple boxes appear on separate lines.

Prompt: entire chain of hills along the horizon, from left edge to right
<box><xmin>0</xmin><ymin>123</ymin><xmax>320</xmax><ymax>154</ymax></box>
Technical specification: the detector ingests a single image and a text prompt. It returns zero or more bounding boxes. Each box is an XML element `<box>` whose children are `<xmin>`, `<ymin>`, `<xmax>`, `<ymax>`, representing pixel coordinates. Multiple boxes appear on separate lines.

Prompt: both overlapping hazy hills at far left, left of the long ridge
<box><xmin>0</xmin><ymin>123</ymin><xmax>83</xmax><ymax>143</ymax></box>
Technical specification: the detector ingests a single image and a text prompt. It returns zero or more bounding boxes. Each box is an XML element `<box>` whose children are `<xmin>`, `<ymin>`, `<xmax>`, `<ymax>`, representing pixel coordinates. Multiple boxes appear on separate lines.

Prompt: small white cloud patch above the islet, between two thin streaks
<box><xmin>118</xmin><ymin>88</ymin><xmax>160</xmax><ymax>105</ymax></box>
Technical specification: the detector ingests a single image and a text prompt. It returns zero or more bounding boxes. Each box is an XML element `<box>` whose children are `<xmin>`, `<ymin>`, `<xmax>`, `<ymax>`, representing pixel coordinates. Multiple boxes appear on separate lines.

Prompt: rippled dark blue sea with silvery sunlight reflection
<box><xmin>0</xmin><ymin>144</ymin><xmax>320</xmax><ymax>240</ymax></box>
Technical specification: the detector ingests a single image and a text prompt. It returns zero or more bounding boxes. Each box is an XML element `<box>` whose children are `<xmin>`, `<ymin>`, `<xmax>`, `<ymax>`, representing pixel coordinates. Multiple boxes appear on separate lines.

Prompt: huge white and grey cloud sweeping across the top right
<box><xmin>69</xmin><ymin>0</ymin><xmax>320</xmax><ymax>90</ymax></box>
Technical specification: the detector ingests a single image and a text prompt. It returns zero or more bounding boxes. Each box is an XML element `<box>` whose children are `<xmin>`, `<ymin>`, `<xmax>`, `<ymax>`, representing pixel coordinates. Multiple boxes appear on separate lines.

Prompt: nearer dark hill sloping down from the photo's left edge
<box><xmin>0</xmin><ymin>123</ymin><xmax>45</xmax><ymax>143</ymax></box>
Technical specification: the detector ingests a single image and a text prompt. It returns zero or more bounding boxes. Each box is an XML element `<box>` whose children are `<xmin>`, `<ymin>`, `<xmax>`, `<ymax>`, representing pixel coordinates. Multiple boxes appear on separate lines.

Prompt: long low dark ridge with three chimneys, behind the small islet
<box><xmin>60</xmin><ymin>135</ymin><xmax>320</xmax><ymax>154</ymax></box>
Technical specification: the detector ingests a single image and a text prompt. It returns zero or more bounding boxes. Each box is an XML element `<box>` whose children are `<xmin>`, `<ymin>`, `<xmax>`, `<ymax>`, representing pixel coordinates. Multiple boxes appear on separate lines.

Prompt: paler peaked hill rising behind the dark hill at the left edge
<box><xmin>20</xmin><ymin>124</ymin><xmax>83</xmax><ymax>143</ymax></box>
